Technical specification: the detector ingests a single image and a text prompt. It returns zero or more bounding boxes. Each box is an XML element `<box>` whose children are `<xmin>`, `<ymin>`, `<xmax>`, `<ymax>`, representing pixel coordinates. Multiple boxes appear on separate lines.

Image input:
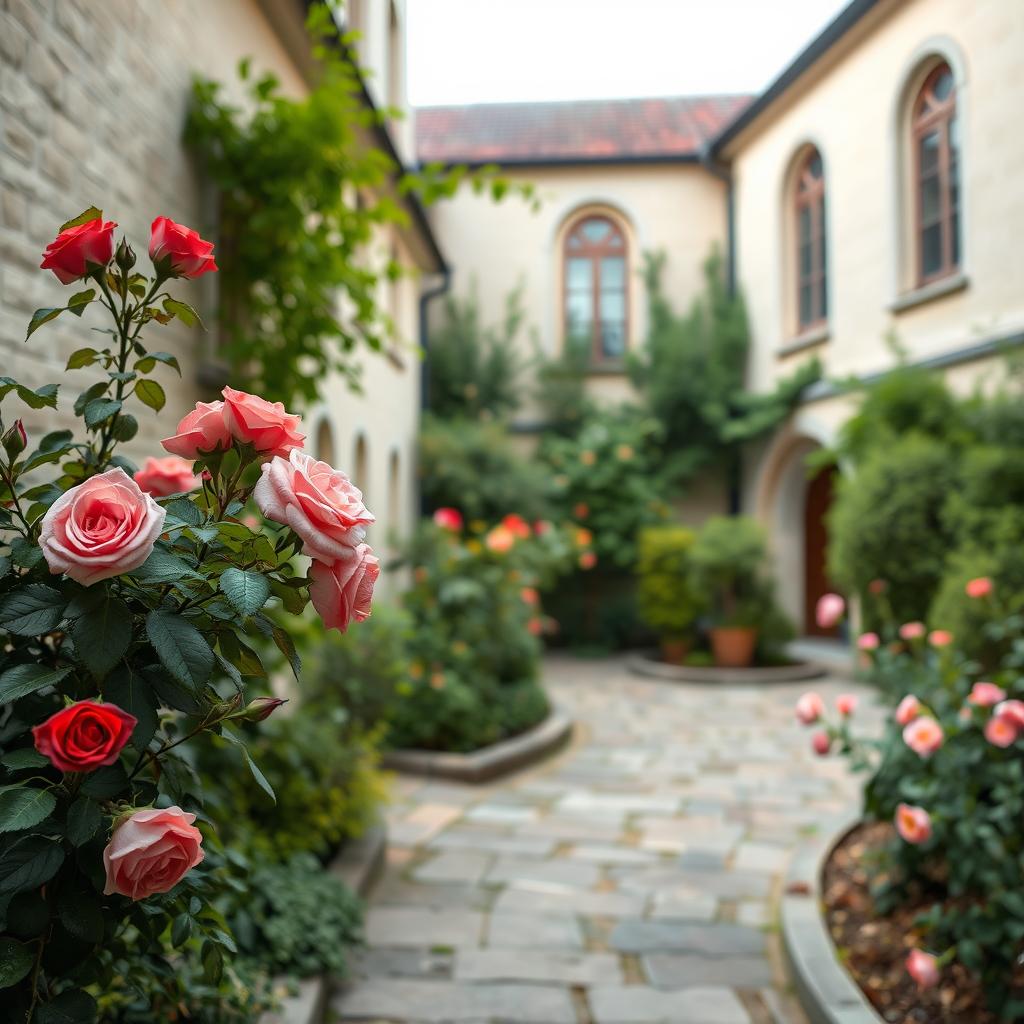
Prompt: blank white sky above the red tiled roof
<box><xmin>408</xmin><ymin>0</ymin><xmax>847</xmax><ymax>106</ymax></box>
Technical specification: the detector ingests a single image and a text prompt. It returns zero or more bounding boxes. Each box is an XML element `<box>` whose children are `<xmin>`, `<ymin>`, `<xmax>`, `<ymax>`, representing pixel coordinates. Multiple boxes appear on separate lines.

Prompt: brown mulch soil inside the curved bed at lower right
<box><xmin>823</xmin><ymin>824</ymin><xmax>996</xmax><ymax>1024</ymax></box>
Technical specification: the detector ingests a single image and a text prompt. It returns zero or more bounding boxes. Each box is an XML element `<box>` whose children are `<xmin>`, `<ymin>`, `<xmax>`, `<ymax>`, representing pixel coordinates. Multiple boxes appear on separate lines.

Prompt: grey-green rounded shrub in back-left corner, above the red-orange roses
<box><xmin>419</xmin><ymin>416</ymin><xmax>551</xmax><ymax>522</ymax></box>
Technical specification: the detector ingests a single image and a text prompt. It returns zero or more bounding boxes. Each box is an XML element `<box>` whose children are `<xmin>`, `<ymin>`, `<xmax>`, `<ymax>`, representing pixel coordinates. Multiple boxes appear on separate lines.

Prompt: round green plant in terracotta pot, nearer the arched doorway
<box><xmin>689</xmin><ymin>516</ymin><xmax>772</xmax><ymax>668</ymax></box>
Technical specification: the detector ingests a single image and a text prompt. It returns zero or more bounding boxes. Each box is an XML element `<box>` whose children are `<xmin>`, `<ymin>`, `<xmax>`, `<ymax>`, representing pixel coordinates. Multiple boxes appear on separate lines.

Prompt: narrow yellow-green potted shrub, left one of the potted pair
<box><xmin>637</xmin><ymin>526</ymin><xmax>700</xmax><ymax>665</ymax></box>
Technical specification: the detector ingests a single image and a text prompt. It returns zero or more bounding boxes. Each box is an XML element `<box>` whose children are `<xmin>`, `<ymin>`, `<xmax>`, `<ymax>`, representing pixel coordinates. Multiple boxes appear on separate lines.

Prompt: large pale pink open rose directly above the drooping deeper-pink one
<box><xmin>253</xmin><ymin>449</ymin><xmax>374</xmax><ymax>562</ymax></box>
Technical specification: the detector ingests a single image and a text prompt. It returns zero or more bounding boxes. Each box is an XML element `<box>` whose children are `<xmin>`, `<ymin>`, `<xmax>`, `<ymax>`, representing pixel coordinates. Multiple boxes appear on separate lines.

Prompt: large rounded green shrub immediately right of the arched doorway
<box><xmin>828</xmin><ymin>435</ymin><xmax>957</xmax><ymax>626</ymax></box>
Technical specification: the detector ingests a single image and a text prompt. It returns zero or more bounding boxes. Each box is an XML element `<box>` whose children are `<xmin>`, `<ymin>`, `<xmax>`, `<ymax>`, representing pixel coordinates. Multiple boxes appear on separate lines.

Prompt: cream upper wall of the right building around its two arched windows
<box><xmin>726</xmin><ymin>0</ymin><xmax>1024</xmax><ymax>390</ymax></box>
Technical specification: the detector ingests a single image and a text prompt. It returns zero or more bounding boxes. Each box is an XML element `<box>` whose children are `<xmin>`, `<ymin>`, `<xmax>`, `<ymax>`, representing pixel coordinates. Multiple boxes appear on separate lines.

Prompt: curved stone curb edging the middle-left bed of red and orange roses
<box><xmin>382</xmin><ymin>709</ymin><xmax>572</xmax><ymax>783</ymax></box>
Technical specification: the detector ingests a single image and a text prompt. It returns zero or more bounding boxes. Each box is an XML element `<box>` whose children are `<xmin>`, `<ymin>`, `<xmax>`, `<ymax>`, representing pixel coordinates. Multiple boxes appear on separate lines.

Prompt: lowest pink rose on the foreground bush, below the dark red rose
<box><xmin>103</xmin><ymin>807</ymin><xmax>203</xmax><ymax>899</ymax></box>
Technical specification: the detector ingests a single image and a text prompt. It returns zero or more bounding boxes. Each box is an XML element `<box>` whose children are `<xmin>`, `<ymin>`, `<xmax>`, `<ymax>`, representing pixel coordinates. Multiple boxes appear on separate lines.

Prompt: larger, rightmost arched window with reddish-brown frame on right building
<box><xmin>910</xmin><ymin>63</ymin><xmax>959</xmax><ymax>285</ymax></box>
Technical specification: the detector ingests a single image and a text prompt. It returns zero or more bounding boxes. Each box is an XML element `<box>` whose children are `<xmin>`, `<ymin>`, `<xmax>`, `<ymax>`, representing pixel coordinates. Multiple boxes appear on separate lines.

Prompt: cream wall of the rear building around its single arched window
<box><xmin>421</xmin><ymin>163</ymin><xmax>726</xmax><ymax>419</ymax></box>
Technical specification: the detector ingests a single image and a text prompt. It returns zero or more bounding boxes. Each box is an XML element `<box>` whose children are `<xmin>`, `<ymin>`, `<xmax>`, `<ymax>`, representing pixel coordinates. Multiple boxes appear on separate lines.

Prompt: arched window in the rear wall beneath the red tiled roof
<box><xmin>564</xmin><ymin>215</ymin><xmax>629</xmax><ymax>362</ymax></box>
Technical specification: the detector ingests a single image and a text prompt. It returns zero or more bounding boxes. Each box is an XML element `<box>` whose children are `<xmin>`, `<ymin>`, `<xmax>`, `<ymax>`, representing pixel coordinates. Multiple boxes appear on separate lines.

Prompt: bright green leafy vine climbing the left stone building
<box><xmin>185</xmin><ymin>3</ymin><xmax>532</xmax><ymax>403</ymax></box>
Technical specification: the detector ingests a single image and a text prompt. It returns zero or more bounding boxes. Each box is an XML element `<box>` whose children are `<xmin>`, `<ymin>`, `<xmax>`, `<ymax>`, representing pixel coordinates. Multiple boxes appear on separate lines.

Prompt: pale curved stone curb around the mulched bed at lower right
<box><xmin>781</xmin><ymin>818</ymin><xmax>885</xmax><ymax>1024</ymax></box>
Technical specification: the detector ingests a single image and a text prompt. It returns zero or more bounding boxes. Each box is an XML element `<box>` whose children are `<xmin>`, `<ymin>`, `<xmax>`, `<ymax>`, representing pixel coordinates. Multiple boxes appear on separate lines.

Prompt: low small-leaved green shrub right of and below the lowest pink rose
<box><xmin>228</xmin><ymin>854</ymin><xmax>361</xmax><ymax>978</ymax></box>
